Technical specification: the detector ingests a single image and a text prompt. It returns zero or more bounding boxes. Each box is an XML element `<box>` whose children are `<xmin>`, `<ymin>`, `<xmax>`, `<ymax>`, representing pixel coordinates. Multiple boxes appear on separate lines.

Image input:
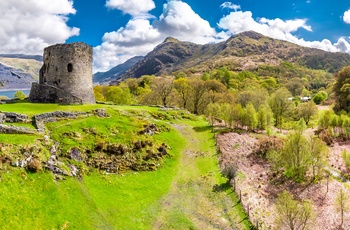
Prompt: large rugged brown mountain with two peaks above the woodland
<box><xmin>117</xmin><ymin>31</ymin><xmax>350</xmax><ymax>81</ymax></box>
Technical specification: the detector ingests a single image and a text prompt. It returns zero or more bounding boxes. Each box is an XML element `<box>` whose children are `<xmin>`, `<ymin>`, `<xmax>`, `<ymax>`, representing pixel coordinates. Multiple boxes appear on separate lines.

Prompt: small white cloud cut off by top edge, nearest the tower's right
<box><xmin>106</xmin><ymin>0</ymin><xmax>156</xmax><ymax>17</ymax></box>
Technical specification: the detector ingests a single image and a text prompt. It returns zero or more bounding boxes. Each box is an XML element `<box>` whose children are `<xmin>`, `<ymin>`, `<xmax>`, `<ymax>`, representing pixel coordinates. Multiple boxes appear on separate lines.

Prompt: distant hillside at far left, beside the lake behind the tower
<box><xmin>0</xmin><ymin>54</ymin><xmax>42</xmax><ymax>89</ymax></box>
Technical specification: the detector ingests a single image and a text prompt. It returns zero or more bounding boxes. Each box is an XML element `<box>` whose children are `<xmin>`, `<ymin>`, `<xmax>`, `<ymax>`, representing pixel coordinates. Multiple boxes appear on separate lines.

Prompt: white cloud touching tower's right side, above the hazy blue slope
<box><xmin>94</xmin><ymin>19</ymin><xmax>164</xmax><ymax>71</ymax></box>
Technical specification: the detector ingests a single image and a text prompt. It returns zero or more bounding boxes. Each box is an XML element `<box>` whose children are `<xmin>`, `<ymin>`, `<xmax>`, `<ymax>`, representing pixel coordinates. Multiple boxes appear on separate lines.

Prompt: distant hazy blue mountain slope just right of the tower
<box><xmin>92</xmin><ymin>56</ymin><xmax>143</xmax><ymax>83</ymax></box>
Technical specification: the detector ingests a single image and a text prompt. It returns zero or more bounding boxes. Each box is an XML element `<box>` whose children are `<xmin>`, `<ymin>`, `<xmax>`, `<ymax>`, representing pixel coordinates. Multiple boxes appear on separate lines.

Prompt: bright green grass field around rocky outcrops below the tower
<box><xmin>0</xmin><ymin>103</ymin><xmax>249</xmax><ymax>229</ymax></box>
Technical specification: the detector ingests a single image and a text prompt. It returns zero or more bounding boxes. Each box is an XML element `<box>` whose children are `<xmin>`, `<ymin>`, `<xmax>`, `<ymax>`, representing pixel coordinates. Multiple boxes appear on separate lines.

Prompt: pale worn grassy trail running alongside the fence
<box><xmin>154</xmin><ymin>125</ymin><xmax>247</xmax><ymax>229</ymax></box>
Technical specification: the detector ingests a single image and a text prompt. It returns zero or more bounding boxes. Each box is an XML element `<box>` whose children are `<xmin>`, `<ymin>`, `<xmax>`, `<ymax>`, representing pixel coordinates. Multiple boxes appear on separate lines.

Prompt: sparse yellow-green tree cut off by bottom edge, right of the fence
<box><xmin>275</xmin><ymin>191</ymin><xmax>313</xmax><ymax>230</ymax></box>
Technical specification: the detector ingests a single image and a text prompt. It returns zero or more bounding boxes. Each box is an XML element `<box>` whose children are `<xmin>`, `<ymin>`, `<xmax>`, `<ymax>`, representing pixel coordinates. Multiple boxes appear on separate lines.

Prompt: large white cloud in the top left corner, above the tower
<box><xmin>0</xmin><ymin>0</ymin><xmax>79</xmax><ymax>54</ymax></box>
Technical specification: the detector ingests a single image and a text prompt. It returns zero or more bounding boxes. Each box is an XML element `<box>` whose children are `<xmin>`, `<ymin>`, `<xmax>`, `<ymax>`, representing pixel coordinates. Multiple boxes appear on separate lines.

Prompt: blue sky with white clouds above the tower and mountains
<box><xmin>0</xmin><ymin>0</ymin><xmax>350</xmax><ymax>71</ymax></box>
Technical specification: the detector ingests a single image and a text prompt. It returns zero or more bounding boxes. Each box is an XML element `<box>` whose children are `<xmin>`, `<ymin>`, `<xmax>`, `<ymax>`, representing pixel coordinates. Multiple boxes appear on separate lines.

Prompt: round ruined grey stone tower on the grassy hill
<box><xmin>29</xmin><ymin>42</ymin><xmax>95</xmax><ymax>104</ymax></box>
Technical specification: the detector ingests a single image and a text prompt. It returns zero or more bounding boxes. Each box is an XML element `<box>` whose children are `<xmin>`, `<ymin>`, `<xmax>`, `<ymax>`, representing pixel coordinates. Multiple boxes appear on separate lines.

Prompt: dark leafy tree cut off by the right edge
<box><xmin>333</xmin><ymin>66</ymin><xmax>350</xmax><ymax>113</ymax></box>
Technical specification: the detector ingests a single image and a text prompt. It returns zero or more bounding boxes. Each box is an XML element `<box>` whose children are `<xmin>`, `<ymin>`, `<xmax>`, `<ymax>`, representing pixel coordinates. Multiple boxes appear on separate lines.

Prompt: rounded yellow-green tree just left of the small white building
<box><xmin>269</xmin><ymin>88</ymin><xmax>292</xmax><ymax>128</ymax></box>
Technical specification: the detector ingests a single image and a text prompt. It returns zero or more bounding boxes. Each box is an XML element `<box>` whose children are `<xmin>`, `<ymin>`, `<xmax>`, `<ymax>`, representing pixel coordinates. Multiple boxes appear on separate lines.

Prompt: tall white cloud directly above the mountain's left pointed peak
<box><xmin>154</xmin><ymin>1</ymin><xmax>216</xmax><ymax>44</ymax></box>
